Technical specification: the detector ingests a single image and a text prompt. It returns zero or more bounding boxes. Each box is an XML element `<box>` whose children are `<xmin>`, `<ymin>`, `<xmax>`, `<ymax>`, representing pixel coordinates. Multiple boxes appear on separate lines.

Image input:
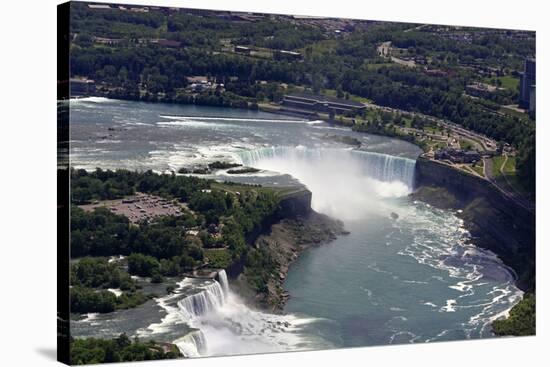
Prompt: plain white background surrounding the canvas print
<box><xmin>0</xmin><ymin>0</ymin><xmax>550</xmax><ymax>367</ymax></box>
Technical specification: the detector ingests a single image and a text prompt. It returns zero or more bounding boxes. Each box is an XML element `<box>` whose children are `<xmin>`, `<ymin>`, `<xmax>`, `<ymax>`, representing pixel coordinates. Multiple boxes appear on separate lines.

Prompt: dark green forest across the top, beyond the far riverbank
<box><xmin>67</xmin><ymin>3</ymin><xmax>535</xmax><ymax>192</ymax></box>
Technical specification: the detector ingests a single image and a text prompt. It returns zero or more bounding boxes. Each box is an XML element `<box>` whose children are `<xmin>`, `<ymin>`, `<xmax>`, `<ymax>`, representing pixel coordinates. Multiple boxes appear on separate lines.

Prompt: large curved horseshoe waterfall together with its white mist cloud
<box><xmin>239</xmin><ymin>146</ymin><xmax>415</xmax><ymax>220</ymax></box>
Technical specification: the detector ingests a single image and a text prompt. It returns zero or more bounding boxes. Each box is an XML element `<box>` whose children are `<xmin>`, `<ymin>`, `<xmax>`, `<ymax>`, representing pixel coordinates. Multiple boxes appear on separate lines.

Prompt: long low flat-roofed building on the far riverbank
<box><xmin>282</xmin><ymin>93</ymin><xmax>366</xmax><ymax>114</ymax></box>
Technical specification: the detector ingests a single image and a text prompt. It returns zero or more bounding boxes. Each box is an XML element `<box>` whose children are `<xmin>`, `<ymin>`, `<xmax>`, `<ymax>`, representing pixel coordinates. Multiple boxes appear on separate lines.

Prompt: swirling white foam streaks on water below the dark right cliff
<box><xmin>399</xmin><ymin>202</ymin><xmax>522</xmax><ymax>340</ymax></box>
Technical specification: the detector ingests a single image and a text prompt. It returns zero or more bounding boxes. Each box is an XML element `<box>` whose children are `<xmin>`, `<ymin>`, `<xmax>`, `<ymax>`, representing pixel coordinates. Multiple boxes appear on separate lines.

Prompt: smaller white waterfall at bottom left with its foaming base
<box><xmin>140</xmin><ymin>270</ymin><xmax>330</xmax><ymax>357</ymax></box>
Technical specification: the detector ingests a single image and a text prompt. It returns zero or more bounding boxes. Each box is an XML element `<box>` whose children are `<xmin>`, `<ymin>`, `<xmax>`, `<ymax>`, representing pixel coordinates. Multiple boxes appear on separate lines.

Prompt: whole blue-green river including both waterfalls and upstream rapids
<box><xmin>71</xmin><ymin>97</ymin><xmax>522</xmax><ymax>356</ymax></box>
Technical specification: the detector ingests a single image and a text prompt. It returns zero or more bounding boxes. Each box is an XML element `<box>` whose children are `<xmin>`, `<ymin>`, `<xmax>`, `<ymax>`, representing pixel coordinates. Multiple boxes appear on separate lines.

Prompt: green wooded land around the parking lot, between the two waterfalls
<box><xmin>71</xmin><ymin>170</ymin><xmax>279</xmax><ymax>313</ymax></box>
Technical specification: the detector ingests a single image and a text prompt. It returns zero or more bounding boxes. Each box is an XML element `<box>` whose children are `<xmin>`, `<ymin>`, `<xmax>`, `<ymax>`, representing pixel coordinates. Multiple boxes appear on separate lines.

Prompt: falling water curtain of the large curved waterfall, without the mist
<box><xmin>238</xmin><ymin>146</ymin><xmax>416</xmax><ymax>190</ymax></box>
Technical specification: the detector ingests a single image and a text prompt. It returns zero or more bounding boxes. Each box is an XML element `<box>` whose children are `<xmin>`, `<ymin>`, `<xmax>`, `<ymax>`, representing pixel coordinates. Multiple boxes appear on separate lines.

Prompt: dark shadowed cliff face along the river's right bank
<box><xmin>413</xmin><ymin>157</ymin><xmax>535</xmax><ymax>291</ymax></box>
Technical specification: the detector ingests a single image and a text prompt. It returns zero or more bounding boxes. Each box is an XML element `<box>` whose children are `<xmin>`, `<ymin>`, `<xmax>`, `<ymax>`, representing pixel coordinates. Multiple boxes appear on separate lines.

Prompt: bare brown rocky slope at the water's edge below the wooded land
<box><xmin>231</xmin><ymin>210</ymin><xmax>349</xmax><ymax>313</ymax></box>
